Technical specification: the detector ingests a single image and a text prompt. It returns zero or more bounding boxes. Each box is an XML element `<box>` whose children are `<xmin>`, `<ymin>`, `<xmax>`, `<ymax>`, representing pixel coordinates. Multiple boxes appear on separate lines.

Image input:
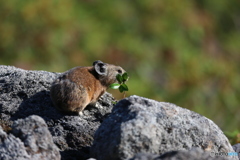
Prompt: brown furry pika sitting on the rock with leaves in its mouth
<box><xmin>50</xmin><ymin>60</ymin><xmax>125</xmax><ymax>115</ymax></box>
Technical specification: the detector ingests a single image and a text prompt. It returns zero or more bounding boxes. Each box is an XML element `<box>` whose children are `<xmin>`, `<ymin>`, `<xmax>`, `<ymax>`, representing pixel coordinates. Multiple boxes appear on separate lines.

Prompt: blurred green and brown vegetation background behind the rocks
<box><xmin>0</xmin><ymin>0</ymin><xmax>240</xmax><ymax>143</ymax></box>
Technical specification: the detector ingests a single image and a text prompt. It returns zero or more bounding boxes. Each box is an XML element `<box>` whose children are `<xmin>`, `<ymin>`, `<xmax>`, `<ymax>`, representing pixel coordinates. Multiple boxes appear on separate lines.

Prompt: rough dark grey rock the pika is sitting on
<box><xmin>0</xmin><ymin>66</ymin><xmax>113</xmax><ymax>160</ymax></box>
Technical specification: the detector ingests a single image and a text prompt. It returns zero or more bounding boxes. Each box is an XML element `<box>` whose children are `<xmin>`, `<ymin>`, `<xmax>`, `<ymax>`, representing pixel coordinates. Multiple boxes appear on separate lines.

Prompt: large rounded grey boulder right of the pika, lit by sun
<box><xmin>91</xmin><ymin>96</ymin><xmax>236</xmax><ymax>160</ymax></box>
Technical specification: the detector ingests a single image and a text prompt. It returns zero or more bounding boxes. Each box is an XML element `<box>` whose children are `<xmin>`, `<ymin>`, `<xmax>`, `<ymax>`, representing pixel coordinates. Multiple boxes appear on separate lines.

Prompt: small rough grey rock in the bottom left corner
<box><xmin>0</xmin><ymin>116</ymin><xmax>60</xmax><ymax>160</ymax></box>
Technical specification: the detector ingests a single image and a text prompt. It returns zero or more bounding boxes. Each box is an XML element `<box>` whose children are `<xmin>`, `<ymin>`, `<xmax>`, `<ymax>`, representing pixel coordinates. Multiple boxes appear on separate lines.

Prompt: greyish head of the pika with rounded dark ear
<box><xmin>93</xmin><ymin>60</ymin><xmax>125</xmax><ymax>86</ymax></box>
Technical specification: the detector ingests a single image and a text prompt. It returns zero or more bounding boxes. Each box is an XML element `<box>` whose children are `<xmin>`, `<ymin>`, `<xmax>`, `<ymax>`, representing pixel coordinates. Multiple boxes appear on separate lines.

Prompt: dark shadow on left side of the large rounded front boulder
<box><xmin>91</xmin><ymin>99</ymin><xmax>137</xmax><ymax>160</ymax></box>
